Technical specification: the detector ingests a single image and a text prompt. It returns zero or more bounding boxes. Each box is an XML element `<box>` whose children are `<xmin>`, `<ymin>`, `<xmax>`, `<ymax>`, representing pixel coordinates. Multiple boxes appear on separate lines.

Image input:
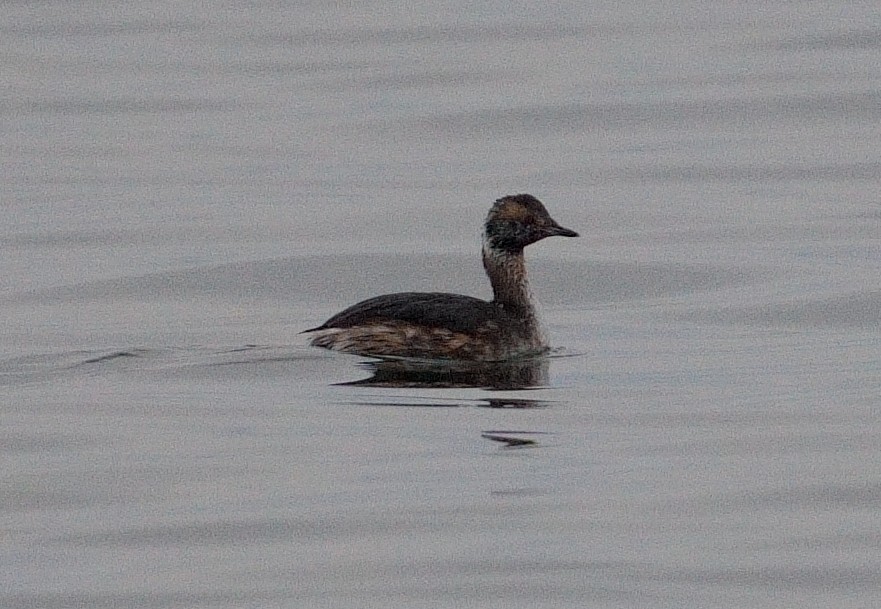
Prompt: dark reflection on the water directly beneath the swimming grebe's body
<box><xmin>340</xmin><ymin>357</ymin><xmax>548</xmax><ymax>390</ymax></box>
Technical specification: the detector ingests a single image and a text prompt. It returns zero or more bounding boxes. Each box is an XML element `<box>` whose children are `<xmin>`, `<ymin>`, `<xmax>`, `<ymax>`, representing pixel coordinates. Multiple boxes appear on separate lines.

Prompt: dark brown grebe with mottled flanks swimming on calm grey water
<box><xmin>304</xmin><ymin>194</ymin><xmax>578</xmax><ymax>361</ymax></box>
